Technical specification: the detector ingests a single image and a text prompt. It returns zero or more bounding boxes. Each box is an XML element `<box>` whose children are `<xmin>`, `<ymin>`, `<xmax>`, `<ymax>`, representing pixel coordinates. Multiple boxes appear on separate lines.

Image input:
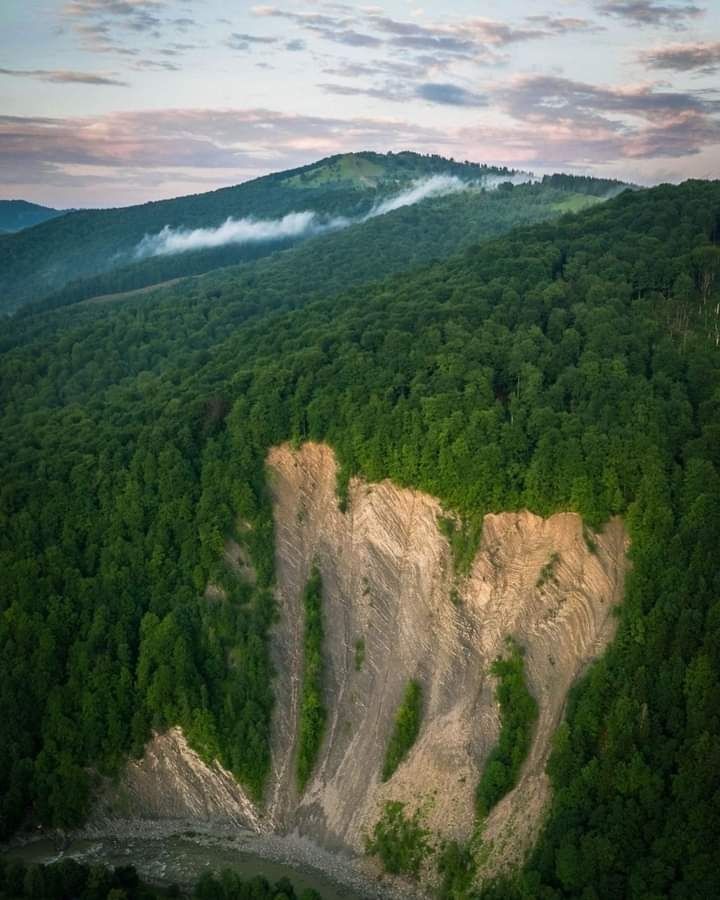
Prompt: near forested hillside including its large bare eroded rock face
<box><xmin>0</xmin><ymin>179</ymin><xmax>720</xmax><ymax>898</ymax></box>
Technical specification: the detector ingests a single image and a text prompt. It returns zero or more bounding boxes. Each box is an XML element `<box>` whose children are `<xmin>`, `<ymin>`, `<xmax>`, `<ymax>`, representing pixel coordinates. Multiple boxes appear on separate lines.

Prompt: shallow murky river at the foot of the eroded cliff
<box><xmin>5</xmin><ymin>831</ymin><xmax>371</xmax><ymax>900</ymax></box>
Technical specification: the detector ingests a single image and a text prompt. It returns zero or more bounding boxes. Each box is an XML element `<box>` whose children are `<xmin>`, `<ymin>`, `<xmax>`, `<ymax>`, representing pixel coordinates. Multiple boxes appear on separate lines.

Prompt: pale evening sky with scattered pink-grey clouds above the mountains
<box><xmin>0</xmin><ymin>0</ymin><xmax>720</xmax><ymax>207</ymax></box>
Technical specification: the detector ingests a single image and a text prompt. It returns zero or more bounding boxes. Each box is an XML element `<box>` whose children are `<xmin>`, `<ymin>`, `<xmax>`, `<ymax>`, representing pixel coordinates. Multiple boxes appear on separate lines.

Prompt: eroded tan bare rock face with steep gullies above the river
<box><xmin>95</xmin><ymin>443</ymin><xmax>626</xmax><ymax>870</ymax></box>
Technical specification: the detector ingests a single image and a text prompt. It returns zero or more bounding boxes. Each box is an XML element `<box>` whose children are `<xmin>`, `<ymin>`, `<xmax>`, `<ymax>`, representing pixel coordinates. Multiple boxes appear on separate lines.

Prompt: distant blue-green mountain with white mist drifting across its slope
<box><xmin>0</xmin><ymin>153</ymin><xmax>621</xmax><ymax>312</ymax></box>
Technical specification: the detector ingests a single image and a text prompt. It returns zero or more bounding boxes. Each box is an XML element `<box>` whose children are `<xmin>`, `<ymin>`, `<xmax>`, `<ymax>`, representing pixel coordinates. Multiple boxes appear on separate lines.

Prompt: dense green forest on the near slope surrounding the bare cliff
<box><xmin>0</xmin><ymin>172</ymin><xmax>720</xmax><ymax>898</ymax></box>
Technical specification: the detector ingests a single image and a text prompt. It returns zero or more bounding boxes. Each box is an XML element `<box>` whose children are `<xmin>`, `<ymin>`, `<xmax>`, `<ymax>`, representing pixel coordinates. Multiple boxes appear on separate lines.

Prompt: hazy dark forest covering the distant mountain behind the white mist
<box><xmin>0</xmin><ymin>153</ymin><xmax>528</xmax><ymax>312</ymax></box>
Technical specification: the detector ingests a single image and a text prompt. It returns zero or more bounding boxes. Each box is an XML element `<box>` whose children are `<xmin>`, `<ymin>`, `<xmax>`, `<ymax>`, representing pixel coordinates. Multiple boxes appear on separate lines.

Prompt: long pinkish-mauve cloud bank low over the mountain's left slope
<box><xmin>0</xmin><ymin>109</ymin><xmax>439</xmax><ymax>183</ymax></box>
